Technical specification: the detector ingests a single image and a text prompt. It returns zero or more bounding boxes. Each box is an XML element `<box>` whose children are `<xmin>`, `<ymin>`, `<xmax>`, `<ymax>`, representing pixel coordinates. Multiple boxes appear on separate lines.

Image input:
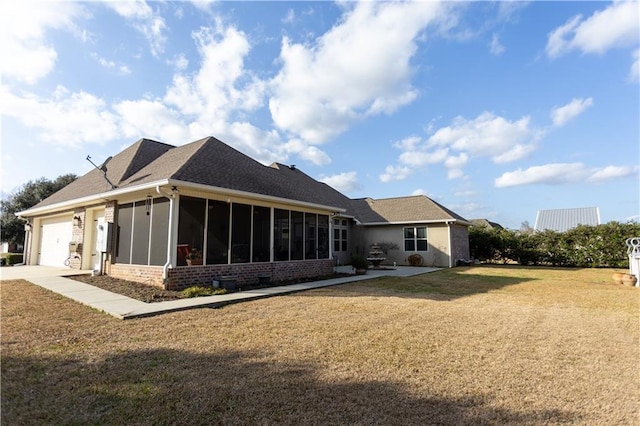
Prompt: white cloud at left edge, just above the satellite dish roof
<box><xmin>1</xmin><ymin>86</ymin><xmax>120</xmax><ymax>146</ymax></box>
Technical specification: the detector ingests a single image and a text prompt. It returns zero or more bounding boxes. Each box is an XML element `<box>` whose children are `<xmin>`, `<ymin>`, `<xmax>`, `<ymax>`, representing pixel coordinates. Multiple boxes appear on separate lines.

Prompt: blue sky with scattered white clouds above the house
<box><xmin>0</xmin><ymin>0</ymin><xmax>640</xmax><ymax>229</ymax></box>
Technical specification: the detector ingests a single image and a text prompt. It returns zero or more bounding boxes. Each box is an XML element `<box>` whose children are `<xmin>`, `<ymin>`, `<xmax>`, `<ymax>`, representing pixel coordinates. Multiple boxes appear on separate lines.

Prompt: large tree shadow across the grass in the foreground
<box><xmin>2</xmin><ymin>350</ymin><xmax>576</xmax><ymax>425</ymax></box>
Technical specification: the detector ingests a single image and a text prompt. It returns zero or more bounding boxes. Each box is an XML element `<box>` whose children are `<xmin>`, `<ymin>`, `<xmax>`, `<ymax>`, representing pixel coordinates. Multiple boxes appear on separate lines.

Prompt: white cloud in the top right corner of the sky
<box><xmin>546</xmin><ymin>1</ymin><xmax>640</xmax><ymax>81</ymax></box>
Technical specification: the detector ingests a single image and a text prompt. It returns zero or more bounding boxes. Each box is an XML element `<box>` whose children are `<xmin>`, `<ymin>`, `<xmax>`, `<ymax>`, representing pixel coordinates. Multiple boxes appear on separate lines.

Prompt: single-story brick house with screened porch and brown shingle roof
<box><xmin>18</xmin><ymin>137</ymin><xmax>470</xmax><ymax>289</ymax></box>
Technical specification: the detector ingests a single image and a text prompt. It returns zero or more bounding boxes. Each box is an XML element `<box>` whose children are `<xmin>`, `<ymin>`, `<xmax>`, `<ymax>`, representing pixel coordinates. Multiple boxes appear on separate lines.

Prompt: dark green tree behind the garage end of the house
<box><xmin>0</xmin><ymin>173</ymin><xmax>78</xmax><ymax>244</ymax></box>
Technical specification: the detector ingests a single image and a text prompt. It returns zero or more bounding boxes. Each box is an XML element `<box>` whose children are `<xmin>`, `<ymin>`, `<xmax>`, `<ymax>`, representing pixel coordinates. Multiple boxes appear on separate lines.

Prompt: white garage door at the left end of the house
<box><xmin>38</xmin><ymin>216</ymin><xmax>72</xmax><ymax>266</ymax></box>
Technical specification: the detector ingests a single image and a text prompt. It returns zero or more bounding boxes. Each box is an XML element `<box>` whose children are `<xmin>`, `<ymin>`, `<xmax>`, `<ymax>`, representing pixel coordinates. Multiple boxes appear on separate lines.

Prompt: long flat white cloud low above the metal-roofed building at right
<box><xmin>494</xmin><ymin>163</ymin><xmax>638</xmax><ymax>188</ymax></box>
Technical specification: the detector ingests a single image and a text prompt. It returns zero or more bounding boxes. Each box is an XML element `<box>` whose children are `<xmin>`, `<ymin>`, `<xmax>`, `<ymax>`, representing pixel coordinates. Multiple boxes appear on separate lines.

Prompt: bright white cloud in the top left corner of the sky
<box><xmin>0</xmin><ymin>1</ymin><xmax>87</xmax><ymax>84</ymax></box>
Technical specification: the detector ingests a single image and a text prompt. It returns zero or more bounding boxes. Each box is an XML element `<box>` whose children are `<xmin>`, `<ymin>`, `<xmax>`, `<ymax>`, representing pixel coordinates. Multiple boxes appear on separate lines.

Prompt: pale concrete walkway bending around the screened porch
<box><xmin>0</xmin><ymin>266</ymin><xmax>439</xmax><ymax>319</ymax></box>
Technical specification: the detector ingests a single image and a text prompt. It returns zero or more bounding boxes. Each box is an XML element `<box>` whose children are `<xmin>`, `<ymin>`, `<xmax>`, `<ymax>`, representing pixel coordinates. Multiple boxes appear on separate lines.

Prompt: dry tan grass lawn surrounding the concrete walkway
<box><xmin>1</xmin><ymin>266</ymin><xmax>640</xmax><ymax>425</ymax></box>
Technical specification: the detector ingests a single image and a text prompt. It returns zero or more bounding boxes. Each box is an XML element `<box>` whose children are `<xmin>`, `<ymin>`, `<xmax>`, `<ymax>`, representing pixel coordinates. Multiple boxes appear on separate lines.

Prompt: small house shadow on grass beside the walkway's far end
<box><xmin>323</xmin><ymin>268</ymin><xmax>535</xmax><ymax>301</ymax></box>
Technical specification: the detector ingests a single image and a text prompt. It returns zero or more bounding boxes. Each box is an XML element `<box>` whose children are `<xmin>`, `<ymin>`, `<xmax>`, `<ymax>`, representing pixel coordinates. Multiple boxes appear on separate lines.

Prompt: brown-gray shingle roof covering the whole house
<box><xmin>26</xmin><ymin>137</ymin><xmax>466</xmax><ymax>223</ymax></box>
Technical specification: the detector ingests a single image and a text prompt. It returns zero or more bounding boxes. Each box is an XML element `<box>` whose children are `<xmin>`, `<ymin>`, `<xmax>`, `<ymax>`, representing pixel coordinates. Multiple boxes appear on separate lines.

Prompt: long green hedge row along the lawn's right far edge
<box><xmin>469</xmin><ymin>222</ymin><xmax>640</xmax><ymax>268</ymax></box>
